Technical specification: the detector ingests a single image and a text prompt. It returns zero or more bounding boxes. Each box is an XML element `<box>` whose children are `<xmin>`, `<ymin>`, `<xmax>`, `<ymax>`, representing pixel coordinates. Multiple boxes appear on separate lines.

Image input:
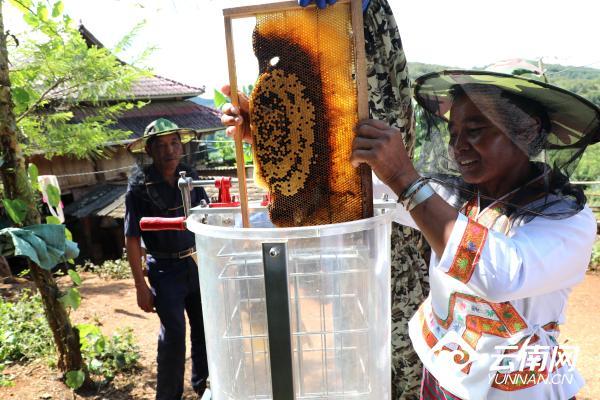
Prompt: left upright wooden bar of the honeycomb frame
<box><xmin>225</xmin><ymin>16</ymin><xmax>250</xmax><ymax>228</ymax></box>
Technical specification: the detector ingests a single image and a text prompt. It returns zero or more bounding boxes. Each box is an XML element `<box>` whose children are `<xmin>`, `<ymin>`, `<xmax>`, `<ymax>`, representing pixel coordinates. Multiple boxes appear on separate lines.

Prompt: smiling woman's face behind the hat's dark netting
<box><xmin>448</xmin><ymin>96</ymin><xmax>529</xmax><ymax>196</ymax></box>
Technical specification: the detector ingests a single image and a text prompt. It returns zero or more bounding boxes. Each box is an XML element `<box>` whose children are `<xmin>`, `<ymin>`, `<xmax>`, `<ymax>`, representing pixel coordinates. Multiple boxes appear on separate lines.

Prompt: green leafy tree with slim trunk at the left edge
<box><xmin>0</xmin><ymin>0</ymin><xmax>148</xmax><ymax>390</ymax></box>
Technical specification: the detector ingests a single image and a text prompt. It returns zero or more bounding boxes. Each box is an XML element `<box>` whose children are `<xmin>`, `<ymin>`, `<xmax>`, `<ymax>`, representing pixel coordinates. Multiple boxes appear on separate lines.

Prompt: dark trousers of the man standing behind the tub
<box><xmin>148</xmin><ymin>257</ymin><xmax>208</xmax><ymax>400</ymax></box>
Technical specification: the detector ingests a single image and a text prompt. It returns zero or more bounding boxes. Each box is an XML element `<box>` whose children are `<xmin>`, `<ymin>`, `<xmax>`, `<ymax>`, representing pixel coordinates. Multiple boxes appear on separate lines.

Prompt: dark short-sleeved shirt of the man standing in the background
<box><xmin>125</xmin><ymin>164</ymin><xmax>209</xmax><ymax>264</ymax></box>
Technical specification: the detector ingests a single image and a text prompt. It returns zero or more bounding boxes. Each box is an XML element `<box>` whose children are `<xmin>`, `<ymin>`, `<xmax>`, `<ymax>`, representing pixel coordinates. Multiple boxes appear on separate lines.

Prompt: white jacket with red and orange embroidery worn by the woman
<box><xmin>398</xmin><ymin>192</ymin><xmax>596</xmax><ymax>400</ymax></box>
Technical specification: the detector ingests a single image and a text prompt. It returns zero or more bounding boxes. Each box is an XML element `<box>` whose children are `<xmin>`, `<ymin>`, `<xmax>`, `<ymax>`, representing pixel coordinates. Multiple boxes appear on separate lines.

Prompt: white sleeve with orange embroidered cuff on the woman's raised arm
<box><xmin>436</xmin><ymin>208</ymin><xmax>596</xmax><ymax>303</ymax></box>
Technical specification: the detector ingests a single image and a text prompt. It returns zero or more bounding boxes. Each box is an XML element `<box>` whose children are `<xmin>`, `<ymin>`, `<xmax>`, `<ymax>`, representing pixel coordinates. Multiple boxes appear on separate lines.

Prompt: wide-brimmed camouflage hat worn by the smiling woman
<box><xmin>413</xmin><ymin>70</ymin><xmax>600</xmax><ymax>150</ymax></box>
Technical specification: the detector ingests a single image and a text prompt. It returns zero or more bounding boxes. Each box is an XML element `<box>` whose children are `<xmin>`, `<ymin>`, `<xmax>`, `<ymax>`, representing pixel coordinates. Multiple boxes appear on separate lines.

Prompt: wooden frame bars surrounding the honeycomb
<box><xmin>223</xmin><ymin>0</ymin><xmax>373</xmax><ymax>228</ymax></box>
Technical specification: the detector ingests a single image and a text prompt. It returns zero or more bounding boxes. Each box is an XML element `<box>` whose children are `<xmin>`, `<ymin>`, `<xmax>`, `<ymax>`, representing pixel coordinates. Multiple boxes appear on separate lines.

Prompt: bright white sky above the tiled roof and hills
<box><xmin>4</xmin><ymin>0</ymin><xmax>600</xmax><ymax>97</ymax></box>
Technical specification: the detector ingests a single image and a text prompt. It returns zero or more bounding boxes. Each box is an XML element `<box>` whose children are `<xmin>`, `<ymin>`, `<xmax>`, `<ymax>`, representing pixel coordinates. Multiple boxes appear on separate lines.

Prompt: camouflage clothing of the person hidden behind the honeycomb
<box><xmin>365</xmin><ymin>0</ymin><xmax>429</xmax><ymax>400</ymax></box>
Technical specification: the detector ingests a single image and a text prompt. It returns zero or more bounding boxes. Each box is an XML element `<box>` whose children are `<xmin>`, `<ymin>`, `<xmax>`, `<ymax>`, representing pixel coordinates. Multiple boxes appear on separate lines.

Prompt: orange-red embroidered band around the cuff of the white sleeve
<box><xmin>448</xmin><ymin>219</ymin><xmax>488</xmax><ymax>283</ymax></box>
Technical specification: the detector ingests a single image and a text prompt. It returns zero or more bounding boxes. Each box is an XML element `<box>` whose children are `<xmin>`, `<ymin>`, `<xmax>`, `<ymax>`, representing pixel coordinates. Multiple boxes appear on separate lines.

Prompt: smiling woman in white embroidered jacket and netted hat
<box><xmin>351</xmin><ymin>71</ymin><xmax>600</xmax><ymax>400</ymax></box>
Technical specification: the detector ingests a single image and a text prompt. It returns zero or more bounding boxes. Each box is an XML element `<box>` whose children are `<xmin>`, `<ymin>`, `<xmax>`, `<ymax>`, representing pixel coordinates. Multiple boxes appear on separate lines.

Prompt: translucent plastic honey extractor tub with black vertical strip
<box><xmin>187</xmin><ymin>209</ymin><xmax>392</xmax><ymax>400</ymax></box>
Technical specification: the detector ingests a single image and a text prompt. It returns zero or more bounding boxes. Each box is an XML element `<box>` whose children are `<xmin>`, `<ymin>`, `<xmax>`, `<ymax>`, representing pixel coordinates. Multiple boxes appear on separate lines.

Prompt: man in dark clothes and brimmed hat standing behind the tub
<box><xmin>125</xmin><ymin>118</ymin><xmax>209</xmax><ymax>400</ymax></box>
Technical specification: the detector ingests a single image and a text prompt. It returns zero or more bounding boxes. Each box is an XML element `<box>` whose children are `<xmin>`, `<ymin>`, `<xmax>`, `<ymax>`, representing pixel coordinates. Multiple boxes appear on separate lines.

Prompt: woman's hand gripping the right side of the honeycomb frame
<box><xmin>350</xmin><ymin>119</ymin><xmax>419</xmax><ymax>196</ymax></box>
